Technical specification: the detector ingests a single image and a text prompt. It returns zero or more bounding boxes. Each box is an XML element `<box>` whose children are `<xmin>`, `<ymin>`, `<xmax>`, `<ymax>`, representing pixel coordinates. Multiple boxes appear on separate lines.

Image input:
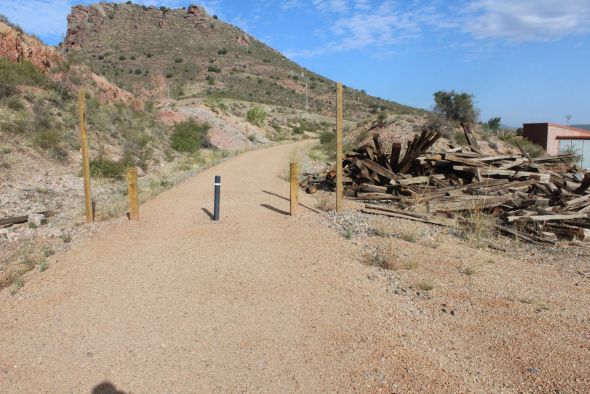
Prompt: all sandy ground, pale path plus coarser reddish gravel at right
<box><xmin>0</xmin><ymin>141</ymin><xmax>590</xmax><ymax>393</ymax></box>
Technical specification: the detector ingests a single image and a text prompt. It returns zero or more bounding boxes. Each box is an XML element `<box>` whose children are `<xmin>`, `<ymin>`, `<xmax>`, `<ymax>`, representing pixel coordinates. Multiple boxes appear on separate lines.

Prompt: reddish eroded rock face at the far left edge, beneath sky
<box><xmin>0</xmin><ymin>22</ymin><xmax>63</xmax><ymax>71</ymax></box>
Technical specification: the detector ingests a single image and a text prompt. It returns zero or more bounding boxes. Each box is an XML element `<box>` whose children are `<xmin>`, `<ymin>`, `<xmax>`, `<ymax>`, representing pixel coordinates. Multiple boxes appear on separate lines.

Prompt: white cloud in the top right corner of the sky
<box><xmin>465</xmin><ymin>0</ymin><xmax>590</xmax><ymax>41</ymax></box>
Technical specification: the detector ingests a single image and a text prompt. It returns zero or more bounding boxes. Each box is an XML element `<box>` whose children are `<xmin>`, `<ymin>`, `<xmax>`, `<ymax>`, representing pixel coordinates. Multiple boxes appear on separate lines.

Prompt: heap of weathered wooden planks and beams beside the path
<box><xmin>301</xmin><ymin>129</ymin><xmax>590</xmax><ymax>244</ymax></box>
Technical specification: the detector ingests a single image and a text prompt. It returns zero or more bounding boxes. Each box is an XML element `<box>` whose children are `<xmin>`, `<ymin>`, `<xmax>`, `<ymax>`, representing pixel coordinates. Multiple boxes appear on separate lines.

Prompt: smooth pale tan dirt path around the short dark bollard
<box><xmin>0</xmin><ymin>146</ymin><xmax>388</xmax><ymax>393</ymax></box>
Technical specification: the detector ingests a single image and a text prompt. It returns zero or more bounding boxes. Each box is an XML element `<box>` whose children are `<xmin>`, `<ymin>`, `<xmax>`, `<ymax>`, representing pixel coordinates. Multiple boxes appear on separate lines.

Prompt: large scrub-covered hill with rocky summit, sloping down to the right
<box><xmin>62</xmin><ymin>3</ymin><xmax>417</xmax><ymax>121</ymax></box>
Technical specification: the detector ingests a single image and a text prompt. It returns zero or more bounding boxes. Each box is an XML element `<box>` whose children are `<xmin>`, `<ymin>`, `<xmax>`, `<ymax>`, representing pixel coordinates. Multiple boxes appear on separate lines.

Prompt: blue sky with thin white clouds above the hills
<box><xmin>0</xmin><ymin>0</ymin><xmax>590</xmax><ymax>126</ymax></box>
